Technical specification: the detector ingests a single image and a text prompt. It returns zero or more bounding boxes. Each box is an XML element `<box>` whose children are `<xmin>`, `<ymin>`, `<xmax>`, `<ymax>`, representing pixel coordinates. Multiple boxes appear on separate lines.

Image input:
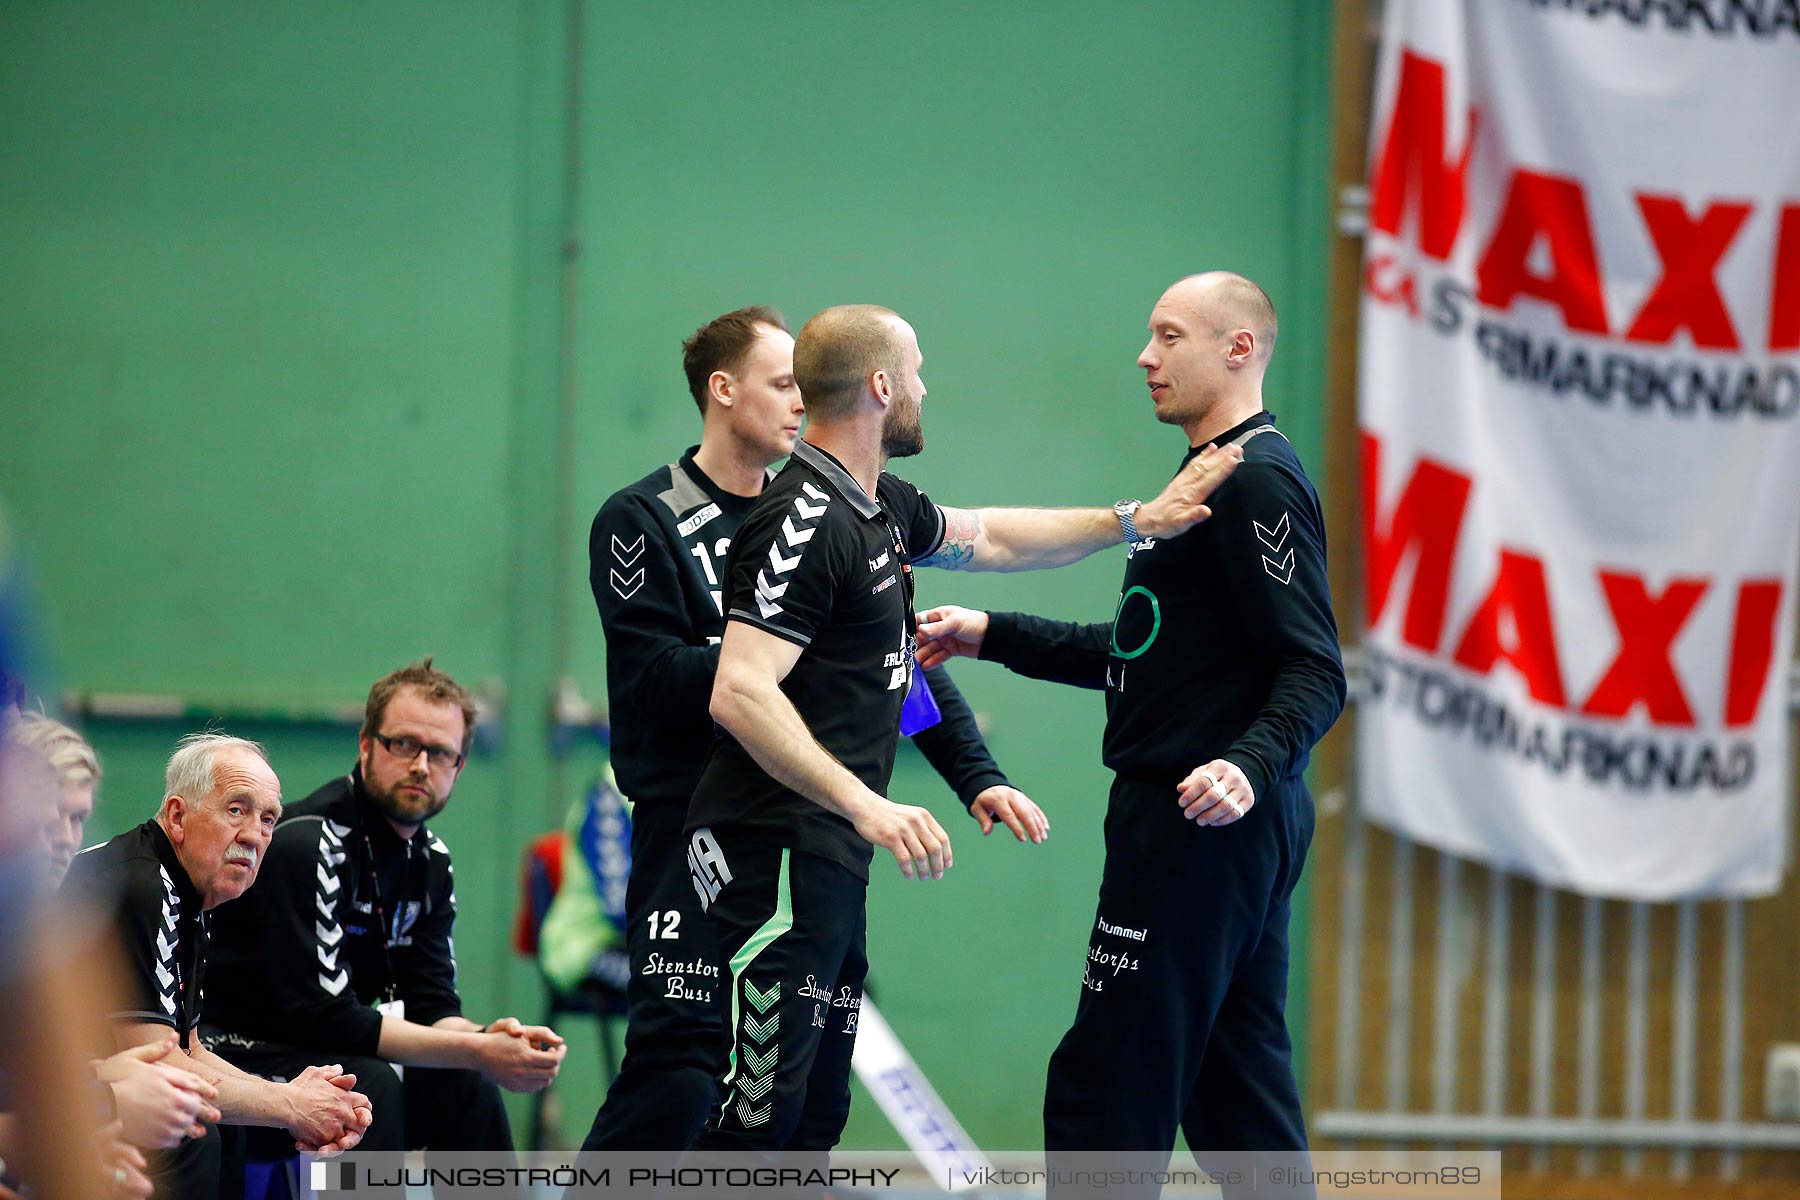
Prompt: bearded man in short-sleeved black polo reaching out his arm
<box><xmin>688</xmin><ymin>306</ymin><xmax>1235</xmax><ymax>1151</ymax></box>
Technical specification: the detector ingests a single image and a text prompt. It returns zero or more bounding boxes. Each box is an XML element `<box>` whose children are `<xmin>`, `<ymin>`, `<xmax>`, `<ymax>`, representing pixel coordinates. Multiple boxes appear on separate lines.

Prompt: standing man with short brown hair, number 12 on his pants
<box><xmin>583</xmin><ymin>308</ymin><xmax>1049</xmax><ymax>1150</ymax></box>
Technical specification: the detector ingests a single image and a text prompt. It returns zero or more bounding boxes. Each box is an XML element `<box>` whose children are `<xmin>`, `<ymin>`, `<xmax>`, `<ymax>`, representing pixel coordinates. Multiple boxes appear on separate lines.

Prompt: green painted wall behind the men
<box><xmin>0</xmin><ymin>0</ymin><xmax>1330</xmax><ymax>1148</ymax></box>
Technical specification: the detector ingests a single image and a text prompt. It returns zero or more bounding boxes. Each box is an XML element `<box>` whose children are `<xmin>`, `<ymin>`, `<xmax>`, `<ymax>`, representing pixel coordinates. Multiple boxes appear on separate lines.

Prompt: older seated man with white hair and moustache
<box><xmin>63</xmin><ymin>734</ymin><xmax>371</xmax><ymax>1200</ymax></box>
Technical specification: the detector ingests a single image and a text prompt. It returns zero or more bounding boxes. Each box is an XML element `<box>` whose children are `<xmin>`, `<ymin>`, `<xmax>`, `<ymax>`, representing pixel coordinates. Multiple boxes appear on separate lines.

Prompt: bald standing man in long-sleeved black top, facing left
<box><xmin>920</xmin><ymin>272</ymin><xmax>1345</xmax><ymax>1196</ymax></box>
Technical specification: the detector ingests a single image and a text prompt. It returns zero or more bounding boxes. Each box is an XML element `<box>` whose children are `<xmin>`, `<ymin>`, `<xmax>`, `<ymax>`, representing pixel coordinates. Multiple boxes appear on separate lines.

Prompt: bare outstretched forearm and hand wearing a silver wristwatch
<box><xmin>916</xmin><ymin>446</ymin><xmax>1244</xmax><ymax>570</ymax></box>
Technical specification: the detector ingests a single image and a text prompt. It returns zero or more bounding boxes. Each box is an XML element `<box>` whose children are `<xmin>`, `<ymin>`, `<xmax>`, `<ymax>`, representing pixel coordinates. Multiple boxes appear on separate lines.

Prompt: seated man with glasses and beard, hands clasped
<box><xmin>205</xmin><ymin>658</ymin><xmax>563</xmax><ymax>1151</ymax></box>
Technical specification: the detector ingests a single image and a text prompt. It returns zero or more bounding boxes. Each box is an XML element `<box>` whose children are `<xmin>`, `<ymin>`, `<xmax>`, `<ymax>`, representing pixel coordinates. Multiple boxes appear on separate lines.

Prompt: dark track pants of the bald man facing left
<box><xmin>1044</xmin><ymin>777</ymin><xmax>1312</xmax><ymax>1196</ymax></box>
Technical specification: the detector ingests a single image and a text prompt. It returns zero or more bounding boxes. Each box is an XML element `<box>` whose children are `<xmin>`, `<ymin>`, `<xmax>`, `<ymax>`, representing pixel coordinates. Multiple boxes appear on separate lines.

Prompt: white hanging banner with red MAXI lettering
<box><xmin>1357</xmin><ymin>0</ymin><xmax>1800</xmax><ymax>900</ymax></box>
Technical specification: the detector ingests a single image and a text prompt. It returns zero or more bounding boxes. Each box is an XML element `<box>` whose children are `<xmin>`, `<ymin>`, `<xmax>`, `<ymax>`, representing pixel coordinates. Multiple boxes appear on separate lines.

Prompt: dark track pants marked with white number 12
<box><xmin>581</xmin><ymin>804</ymin><xmax>729</xmax><ymax>1151</ymax></box>
